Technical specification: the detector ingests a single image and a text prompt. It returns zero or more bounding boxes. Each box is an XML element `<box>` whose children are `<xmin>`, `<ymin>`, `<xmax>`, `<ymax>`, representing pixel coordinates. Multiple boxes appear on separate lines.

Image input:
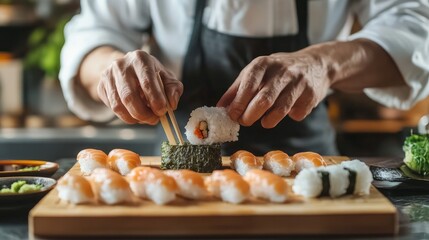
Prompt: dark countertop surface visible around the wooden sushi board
<box><xmin>0</xmin><ymin>158</ymin><xmax>429</xmax><ymax>240</ymax></box>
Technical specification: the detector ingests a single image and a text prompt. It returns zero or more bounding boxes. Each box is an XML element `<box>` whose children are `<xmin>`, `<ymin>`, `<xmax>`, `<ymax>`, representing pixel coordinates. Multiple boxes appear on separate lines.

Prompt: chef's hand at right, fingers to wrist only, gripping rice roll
<box><xmin>217</xmin><ymin>51</ymin><xmax>330</xmax><ymax>128</ymax></box>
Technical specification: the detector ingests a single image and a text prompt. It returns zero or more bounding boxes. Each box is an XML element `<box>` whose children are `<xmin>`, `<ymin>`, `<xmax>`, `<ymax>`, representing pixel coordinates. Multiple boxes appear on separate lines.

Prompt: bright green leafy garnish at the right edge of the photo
<box><xmin>403</xmin><ymin>134</ymin><xmax>429</xmax><ymax>176</ymax></box>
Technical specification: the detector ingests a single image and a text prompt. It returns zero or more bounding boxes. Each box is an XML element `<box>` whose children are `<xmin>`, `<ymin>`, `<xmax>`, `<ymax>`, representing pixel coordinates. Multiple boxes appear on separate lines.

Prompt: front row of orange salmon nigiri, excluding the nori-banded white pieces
<box><xmin>57</xmin><ymin>167</ymin><xmax>290</xmax><ymax>205</ymax></box>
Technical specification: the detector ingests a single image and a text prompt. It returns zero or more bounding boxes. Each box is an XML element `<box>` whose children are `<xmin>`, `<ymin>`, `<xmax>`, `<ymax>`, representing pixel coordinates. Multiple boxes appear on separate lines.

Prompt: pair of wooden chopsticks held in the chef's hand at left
<box><xmin>158</xmin><ymin>72</ymin><xmax>184</xmax><ymax>145</ymax></box>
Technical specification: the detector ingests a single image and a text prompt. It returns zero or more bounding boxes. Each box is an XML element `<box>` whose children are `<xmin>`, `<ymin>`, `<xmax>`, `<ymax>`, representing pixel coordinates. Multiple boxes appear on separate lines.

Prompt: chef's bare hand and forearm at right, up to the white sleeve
<box><xmin>217</xmin><ymin>39</ymin><xmax>406</xmax><ymax>128</ymax></box>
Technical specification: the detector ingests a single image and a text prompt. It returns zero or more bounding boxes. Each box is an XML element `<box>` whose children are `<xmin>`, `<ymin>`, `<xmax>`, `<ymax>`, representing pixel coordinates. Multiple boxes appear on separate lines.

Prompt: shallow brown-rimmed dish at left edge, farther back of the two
<box><xmin>0</xmin><ymin>160</ymin><xmax>59</xmax><ymax>177</ymax></box>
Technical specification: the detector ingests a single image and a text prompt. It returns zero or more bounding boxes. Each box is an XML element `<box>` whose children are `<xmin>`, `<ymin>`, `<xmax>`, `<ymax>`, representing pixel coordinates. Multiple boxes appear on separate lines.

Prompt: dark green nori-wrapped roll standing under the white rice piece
<box><xmin>161</xmin><ymin>142</ymin><xmax>222</xmax><ymax>173</ymax></box>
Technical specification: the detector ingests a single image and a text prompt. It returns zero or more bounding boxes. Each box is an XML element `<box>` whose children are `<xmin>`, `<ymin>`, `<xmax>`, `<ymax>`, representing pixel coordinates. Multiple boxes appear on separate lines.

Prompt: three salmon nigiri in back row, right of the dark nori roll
<box><xmin>230</xmin><ymin>150</ymin><xmax>327</xmax><ymax>177</ymax></box>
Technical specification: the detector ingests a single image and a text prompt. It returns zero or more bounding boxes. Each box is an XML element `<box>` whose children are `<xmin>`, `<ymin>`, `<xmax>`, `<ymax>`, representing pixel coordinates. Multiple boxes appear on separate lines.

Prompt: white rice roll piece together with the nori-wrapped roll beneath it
<box><xmin>161</xmin><ymin>106</ymin><xmax>240</xmax><ymax>173</ymax></box>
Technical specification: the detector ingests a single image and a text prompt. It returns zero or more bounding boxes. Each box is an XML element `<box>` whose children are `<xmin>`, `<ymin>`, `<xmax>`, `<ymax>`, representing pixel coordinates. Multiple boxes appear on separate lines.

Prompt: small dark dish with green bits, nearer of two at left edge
<box><xmin>0</xmin><ymin>176</ymin><xmax>57</xmax><ymax>207</ymax></box>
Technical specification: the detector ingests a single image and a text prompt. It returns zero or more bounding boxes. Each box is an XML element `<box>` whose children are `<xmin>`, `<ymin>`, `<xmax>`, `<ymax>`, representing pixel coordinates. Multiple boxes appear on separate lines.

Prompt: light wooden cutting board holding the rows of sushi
<box><xmin>29</xmin><ymin>157</ymin><xmax>397</xmax><ymax>237</ymax></box>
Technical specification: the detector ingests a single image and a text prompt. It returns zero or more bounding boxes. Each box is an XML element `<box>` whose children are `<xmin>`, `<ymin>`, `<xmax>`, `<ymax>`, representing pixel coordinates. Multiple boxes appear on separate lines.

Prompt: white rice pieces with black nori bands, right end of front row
<box><xmin>293</xmin><ymin>160</ymin><xmax>373</xmax><ymax>198</ymax></box>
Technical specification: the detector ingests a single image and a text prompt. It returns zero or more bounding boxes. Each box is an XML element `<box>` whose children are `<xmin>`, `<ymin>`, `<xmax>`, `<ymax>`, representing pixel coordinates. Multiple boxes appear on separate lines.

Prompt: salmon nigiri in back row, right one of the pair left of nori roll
<box><xmin>107</xmin><ymin>149</ymin><xmax>141</xmax><ymax>176</ymax></box>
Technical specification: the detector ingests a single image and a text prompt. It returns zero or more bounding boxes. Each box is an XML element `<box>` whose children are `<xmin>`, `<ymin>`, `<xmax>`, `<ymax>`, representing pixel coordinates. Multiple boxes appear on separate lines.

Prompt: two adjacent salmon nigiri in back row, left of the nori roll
<box><xmin>77</xmin><ymin>148</ymin><xmax>141</xmax><ymax>175</ymax></box>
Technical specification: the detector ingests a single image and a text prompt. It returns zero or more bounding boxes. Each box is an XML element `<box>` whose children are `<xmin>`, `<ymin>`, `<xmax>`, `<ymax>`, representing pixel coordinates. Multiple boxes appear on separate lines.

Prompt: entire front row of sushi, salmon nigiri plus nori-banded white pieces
<box><xmin>57</xmin><ymin>160</ymin><xmax>373</xmax><ymax>204</ymax></box>
